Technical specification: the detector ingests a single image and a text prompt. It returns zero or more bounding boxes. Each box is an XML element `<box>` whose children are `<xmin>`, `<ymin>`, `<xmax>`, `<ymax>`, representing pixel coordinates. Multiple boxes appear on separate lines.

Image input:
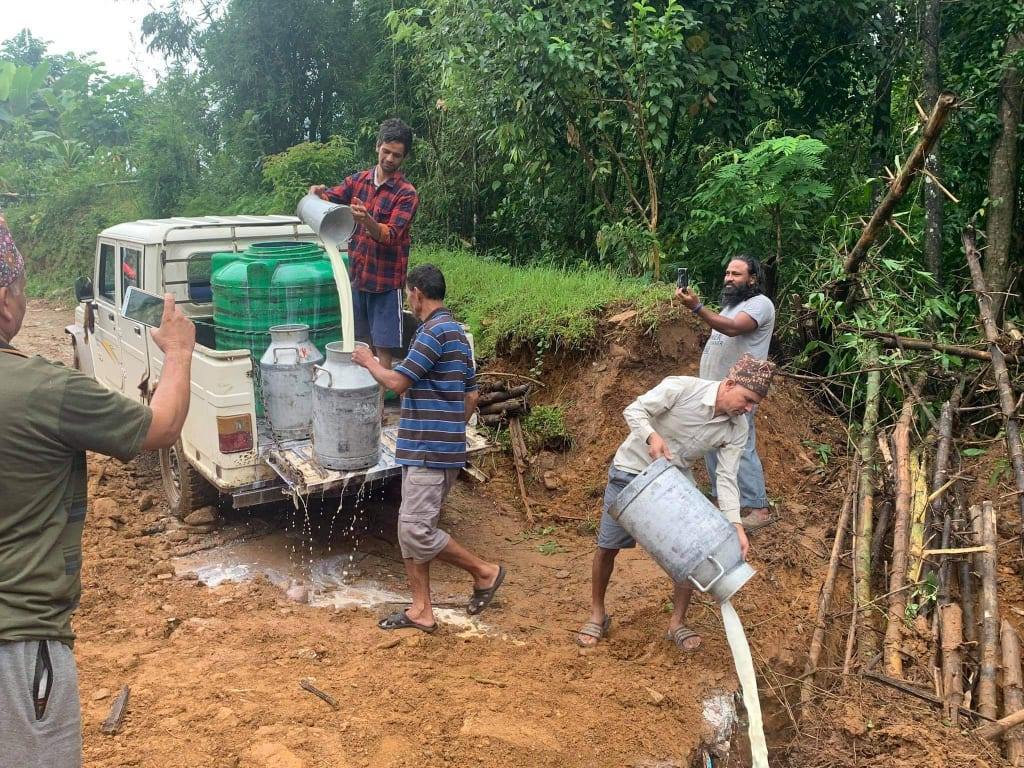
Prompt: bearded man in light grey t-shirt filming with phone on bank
<box><xmin>676</xmin><ymin>254</ymin><xmax>775</xmax><ymax>531</ymax></box>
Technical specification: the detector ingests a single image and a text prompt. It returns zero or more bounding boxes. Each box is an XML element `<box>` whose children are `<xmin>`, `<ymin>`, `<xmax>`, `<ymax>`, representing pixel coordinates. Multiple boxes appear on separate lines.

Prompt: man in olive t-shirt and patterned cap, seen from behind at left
<box><xmin>0</xmin><ymin>215</ymin><xmax>196</xmax><ymax>768</ymax></box>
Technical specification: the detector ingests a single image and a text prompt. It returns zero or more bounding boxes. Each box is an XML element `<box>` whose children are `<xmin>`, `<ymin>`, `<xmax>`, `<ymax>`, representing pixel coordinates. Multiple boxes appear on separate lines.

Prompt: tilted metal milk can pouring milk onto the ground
<box><xmin>608</xmin><ymin>459</ymin><xmax>755</xmax><ymax>602</ymax></box>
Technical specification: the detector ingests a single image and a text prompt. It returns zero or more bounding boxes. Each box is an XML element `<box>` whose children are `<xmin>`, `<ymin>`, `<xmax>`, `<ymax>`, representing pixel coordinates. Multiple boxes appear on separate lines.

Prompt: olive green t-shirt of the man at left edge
<box><xmin>0</xmin><ymin>344</ymin><xmax>153</xmax><ymax>645</ymax></box>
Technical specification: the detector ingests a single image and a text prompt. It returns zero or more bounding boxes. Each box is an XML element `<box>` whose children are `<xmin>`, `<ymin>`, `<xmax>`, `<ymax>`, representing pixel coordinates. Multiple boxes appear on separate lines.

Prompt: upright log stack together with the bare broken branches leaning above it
<box><xmin>794</xmin><ymin>88</ymin><xmax>1024</xmax><ymax>767</ymax></box>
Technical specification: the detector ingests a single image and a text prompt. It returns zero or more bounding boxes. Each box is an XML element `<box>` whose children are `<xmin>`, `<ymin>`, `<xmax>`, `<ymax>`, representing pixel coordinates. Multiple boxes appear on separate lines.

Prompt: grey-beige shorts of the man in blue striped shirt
<box><xmin>398</xmin><ymin>467</ymin><xmax>459</xmax><ymax>563</ymax></box>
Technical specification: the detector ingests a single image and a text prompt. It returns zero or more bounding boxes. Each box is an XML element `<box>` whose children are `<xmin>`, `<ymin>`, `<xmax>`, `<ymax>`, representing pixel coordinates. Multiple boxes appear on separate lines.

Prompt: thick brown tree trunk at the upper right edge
<box><xmin>985</xmin><ymin>31</ymin><xmax>1024</xmax><ymax>322</ymax></box>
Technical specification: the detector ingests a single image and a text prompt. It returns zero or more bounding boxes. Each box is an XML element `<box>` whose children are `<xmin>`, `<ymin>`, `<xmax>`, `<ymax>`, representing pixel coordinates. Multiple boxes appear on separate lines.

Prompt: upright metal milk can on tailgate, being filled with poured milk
<box><xmin>312</xmin><ymin>341</ymin><xmax>384</xmax><ymax>471</ymax></box>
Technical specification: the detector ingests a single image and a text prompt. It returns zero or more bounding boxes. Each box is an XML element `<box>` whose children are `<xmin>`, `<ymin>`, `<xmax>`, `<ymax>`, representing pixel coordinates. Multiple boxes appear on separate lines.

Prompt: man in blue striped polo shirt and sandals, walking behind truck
<box><xmin>352</xmin><ymin>264</ymin><xmax>505</xmax><ymax>632</ymax></box>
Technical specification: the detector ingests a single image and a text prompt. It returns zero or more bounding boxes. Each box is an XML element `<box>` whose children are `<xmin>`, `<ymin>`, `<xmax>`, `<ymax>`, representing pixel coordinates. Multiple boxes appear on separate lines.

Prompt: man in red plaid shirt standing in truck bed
<box><xmin>309</xmin><ymin>118</ymin><xmax>420</xmax><ymax>368</ymax></box>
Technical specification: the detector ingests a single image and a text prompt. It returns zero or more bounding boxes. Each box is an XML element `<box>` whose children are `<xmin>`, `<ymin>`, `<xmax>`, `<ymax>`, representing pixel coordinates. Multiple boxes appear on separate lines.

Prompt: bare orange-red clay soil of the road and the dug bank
<box><xmin>17</xmin><ymin>302</ymin><xmax>1020</xmax><ymax>768</ymax></box>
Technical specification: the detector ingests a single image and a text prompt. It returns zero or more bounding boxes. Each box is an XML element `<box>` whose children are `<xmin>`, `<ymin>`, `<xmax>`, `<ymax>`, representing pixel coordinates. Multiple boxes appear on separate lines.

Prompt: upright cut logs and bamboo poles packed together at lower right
<box><xmin>801</xmin><ymin>391</ymin><xmax>1024</xmax><ymax>766</ymax></box>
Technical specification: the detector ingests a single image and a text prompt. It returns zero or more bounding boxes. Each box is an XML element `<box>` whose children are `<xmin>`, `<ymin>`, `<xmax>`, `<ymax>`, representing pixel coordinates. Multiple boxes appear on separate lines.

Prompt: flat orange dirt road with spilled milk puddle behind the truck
<box><xmin>17</xmin><ymin>303</ymin><xmax>744</xmax><ymax>768</ymax></box>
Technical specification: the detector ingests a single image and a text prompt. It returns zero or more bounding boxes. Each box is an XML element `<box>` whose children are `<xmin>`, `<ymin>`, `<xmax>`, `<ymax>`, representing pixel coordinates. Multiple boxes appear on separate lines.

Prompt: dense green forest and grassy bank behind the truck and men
<box><xmin>0</xmin><ymin>0</ymin><xmax>1024</xmax><ymax>385</ymax></box>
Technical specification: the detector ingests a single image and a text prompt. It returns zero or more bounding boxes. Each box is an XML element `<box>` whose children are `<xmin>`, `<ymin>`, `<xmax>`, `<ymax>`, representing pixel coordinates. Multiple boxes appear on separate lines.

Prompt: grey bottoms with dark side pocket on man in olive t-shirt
<box><xmin>0</xmin><ymin>640</ymin><xmax>82</xmax><ymax>768</ymax></box>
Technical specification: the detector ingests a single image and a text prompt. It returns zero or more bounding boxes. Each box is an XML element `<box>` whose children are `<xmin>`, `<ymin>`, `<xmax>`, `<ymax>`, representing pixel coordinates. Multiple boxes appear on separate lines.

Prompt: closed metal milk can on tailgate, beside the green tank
<box><xmin>259</xmin><ymin>323</ymin><xmax>324</xmax><ymax>440</ymax></box>
